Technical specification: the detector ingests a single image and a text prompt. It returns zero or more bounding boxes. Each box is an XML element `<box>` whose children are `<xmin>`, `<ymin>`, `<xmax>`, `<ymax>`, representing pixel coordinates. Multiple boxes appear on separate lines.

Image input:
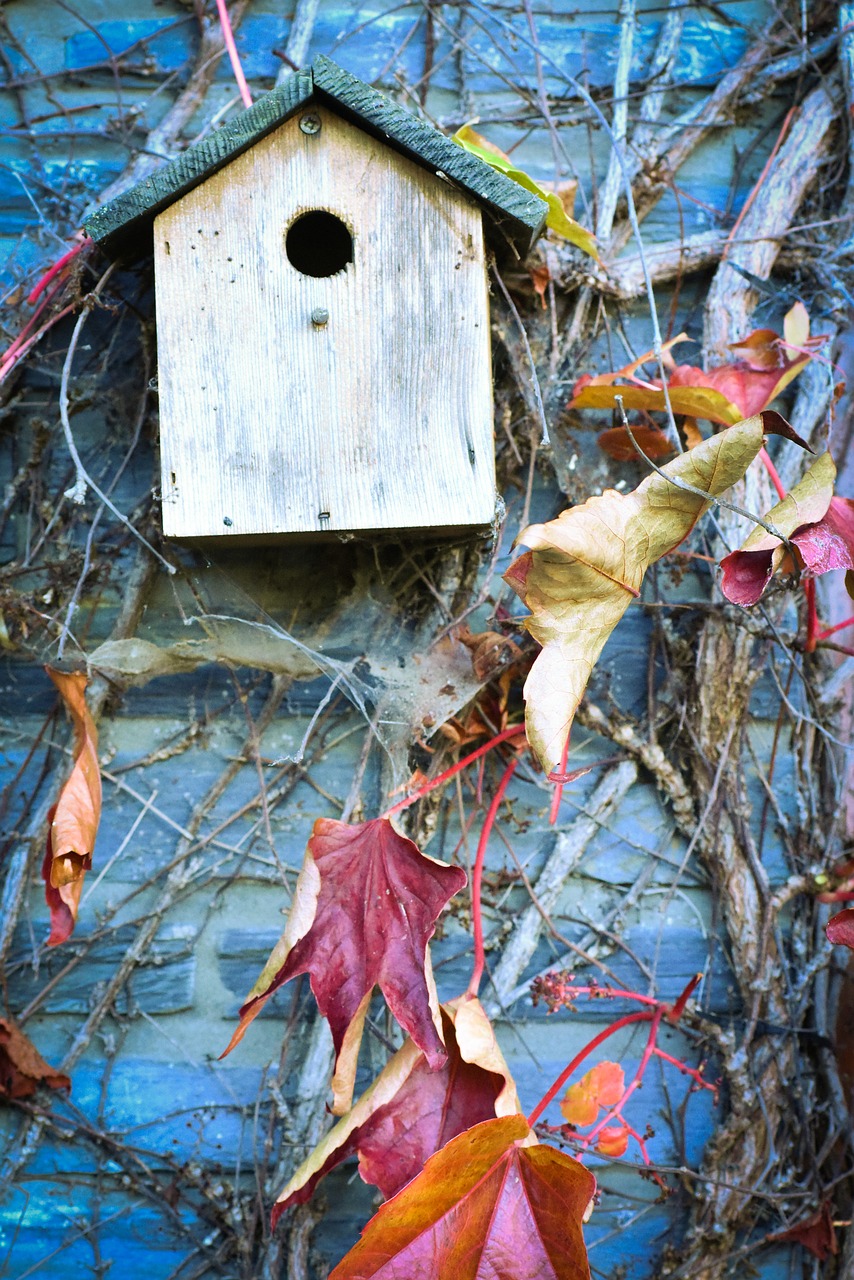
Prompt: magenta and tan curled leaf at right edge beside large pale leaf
<box><xmin>721</xmin><ymin>453</ymin><xmax>854</xmax><ymax>607</ymax></box>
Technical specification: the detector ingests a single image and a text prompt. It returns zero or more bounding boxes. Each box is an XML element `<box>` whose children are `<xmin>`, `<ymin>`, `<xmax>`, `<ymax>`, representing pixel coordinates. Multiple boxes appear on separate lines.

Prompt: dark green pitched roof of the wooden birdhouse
<box><xmin>83</xmin><ymin>56</ymin><xmax>548</xmax><ymax>257</ymax></box>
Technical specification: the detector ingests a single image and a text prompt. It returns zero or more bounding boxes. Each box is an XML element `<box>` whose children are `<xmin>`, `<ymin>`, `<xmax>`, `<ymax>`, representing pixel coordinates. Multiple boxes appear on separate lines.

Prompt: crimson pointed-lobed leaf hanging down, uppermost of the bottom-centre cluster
<box><xmin>223</xmin><ymin>818</ymin><xmax>466</xmax><ymax>1115</ymax></box>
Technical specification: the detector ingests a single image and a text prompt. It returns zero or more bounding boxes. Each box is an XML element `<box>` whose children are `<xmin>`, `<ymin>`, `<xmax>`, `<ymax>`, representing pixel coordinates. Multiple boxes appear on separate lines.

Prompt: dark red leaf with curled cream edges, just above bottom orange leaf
<box><xmin>273</xmin><ymin>997</ymin><xmax>520</xmax><ymax>1226</ymax></box>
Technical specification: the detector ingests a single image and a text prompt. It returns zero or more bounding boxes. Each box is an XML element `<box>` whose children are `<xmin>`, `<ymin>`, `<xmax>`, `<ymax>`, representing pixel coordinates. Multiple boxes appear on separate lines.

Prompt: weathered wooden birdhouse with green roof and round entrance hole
<box><xmin>86</xmin><ymin>58</ymin><xmax>547</xmax><ymax>540</ymax></box>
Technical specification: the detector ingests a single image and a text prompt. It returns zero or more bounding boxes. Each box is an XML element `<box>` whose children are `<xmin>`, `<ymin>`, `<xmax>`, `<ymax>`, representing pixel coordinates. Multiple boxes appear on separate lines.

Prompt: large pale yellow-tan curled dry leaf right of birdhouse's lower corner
<box><xmin>504</xmin><ymin>416</ymin><xmax>763</xmax><ymax>773</ymax></box>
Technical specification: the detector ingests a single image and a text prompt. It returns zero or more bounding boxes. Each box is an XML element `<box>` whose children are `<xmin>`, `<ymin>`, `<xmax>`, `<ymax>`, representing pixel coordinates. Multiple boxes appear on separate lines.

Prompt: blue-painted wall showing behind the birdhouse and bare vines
<box><xmin>0</xmin><ymin>0</ymin><xmax>809</xmax><ymax>1280</ymax></box>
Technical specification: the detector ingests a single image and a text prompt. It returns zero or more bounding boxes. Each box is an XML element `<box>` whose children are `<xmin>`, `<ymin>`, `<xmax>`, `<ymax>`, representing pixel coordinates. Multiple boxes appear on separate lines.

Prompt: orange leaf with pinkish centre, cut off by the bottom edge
<box><xmin>329</xmin><ymin>1116</ymin><xmax>595</xmax><ymax>1280</ymax></box>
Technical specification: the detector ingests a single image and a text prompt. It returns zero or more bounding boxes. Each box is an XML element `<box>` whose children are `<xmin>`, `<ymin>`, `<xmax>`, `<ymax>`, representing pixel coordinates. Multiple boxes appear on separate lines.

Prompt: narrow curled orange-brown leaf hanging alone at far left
<box><xmin>42</xmin><ymin>667</ymin><xmax>101</xmax><ymax>947</ymax></box>
